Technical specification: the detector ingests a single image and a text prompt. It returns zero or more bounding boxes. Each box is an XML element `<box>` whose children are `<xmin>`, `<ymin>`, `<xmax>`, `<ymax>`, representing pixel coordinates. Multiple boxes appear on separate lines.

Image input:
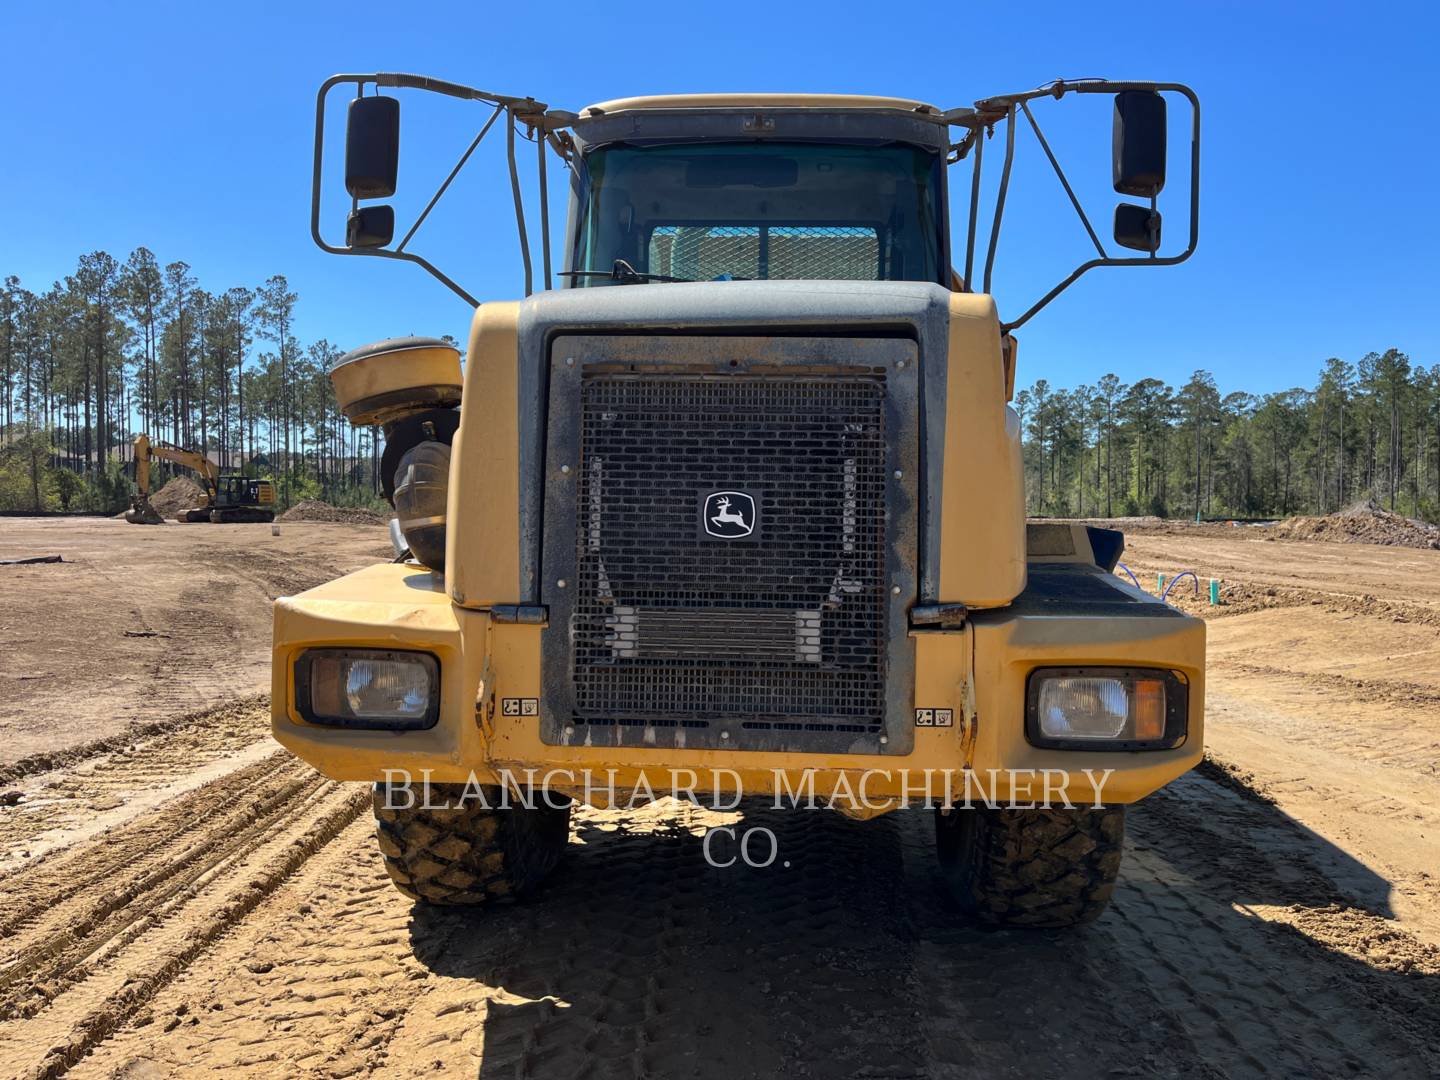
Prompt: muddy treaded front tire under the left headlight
<box><xmin>372</xmin><ymin>783</ymin><xmax>570</xmax><ymax>904</ymax></box>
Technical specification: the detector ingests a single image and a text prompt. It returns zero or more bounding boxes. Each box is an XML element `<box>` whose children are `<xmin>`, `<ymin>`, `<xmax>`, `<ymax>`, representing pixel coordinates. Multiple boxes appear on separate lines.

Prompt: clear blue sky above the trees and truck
<box><xmin>0</xmin><ymin>3</ymin><xmax>1440</xmax><ymax>392</ymax></box>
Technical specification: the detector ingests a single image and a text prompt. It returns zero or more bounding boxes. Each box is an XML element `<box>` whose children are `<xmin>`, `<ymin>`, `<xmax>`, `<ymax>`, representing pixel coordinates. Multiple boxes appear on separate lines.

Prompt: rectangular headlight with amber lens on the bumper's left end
<box><xmin>295</xmin><ymin>649</ymin><xmax>441</xmax><ymax>730</ymax></box>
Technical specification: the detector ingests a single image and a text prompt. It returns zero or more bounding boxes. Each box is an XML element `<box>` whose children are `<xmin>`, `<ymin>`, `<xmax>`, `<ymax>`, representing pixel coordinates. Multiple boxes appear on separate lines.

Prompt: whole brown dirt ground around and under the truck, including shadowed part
<box><xmin>0</xmin><ymin>520</ymin><xmax>1440</xmax><ymax>1080</ymax></box>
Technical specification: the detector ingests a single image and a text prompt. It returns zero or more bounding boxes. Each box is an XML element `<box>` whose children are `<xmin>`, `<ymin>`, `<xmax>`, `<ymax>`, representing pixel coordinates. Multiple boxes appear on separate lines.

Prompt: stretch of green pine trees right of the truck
<box><xmin>1014</xmin><ymin>348</ymin><xmax>1440</xmax><ymax>521</ymax></box>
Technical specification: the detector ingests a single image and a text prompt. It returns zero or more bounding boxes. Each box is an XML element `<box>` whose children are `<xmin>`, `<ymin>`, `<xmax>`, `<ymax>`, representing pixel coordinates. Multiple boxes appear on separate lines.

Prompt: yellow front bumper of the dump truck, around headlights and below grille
<box><xmin>271</xmin><ymin>564</ymin><xmax>1205</xmax><ymax>812</ymax></box>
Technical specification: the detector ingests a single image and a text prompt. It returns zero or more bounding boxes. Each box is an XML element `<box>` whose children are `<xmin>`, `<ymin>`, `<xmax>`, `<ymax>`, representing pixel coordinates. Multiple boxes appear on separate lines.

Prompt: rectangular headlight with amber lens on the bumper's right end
<box><xmin>1025</xmin><ymin>668</ymin><xmax>1189</xmax><ymax>750</ymax></box>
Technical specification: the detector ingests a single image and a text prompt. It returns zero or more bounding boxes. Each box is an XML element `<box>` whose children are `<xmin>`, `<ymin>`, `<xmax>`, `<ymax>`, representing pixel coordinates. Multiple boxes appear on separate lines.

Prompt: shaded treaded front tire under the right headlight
<box><xmin>935</xmin><ymin>806</ymin><xmax>1125</xmax><ymax>926</ymax></box>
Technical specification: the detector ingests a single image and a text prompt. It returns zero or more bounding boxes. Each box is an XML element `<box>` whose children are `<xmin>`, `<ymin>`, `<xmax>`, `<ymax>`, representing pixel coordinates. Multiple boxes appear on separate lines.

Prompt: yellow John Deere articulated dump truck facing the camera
<box><xmin>272</xmin><ymin>73</ymin><xmax>1205</xmax><ymax>926</ymax></box>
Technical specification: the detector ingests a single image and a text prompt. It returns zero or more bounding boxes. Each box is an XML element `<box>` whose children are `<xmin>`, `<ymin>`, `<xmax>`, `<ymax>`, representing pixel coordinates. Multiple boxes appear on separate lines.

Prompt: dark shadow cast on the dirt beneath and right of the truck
<box><xmin>410</xmin><ymin>775</ymin><xmax>1440</xmax><ymax>1080</ymax></box>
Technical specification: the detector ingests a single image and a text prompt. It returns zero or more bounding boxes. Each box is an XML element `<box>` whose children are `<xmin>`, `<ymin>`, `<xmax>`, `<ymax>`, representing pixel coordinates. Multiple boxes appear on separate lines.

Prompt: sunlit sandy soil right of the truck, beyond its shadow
<box><xmin>1125</xmin><ymin>527</ymin><xmax>1440</xmax><ymax>943</ymax></box>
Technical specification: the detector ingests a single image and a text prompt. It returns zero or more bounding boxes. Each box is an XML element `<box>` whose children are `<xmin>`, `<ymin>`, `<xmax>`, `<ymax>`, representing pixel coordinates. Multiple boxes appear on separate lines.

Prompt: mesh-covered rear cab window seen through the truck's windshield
<box><xmin>648</xmin><ymin>225</ymin><xmax>880</xmax><ymax>281</ymax></box>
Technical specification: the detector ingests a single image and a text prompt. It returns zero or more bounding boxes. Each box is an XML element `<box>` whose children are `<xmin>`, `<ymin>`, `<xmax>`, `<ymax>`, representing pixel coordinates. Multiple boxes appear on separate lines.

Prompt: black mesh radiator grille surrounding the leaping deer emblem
<box><xmin>570</xmin><ymin>369</ymin><xmax>888</xmax><ymax>732</ymax></box>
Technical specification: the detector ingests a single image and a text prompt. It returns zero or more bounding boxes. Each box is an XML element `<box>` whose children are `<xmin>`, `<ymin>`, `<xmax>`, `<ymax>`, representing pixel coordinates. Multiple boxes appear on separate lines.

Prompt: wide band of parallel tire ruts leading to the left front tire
<box><xmin>0</xmin><ymin>708</ymin><xmax>366</xmax><ymax>1077</ymax></box>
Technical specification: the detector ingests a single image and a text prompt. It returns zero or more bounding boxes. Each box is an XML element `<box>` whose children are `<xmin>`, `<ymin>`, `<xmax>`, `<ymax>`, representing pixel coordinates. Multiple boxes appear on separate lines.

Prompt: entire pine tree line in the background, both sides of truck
<box><xmin>0</xmin><ymin>256</ymin><xmax>1440</xmax><ymax>520</ymax></box>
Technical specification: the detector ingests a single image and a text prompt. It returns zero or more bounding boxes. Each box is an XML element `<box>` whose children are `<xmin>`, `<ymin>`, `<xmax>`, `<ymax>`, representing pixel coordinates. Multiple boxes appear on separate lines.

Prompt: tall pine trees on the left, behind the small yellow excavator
<box><xmin>0</xmin><ymin>248</ymin><xmax>377</xmax><ymax>511</ymax></box>
